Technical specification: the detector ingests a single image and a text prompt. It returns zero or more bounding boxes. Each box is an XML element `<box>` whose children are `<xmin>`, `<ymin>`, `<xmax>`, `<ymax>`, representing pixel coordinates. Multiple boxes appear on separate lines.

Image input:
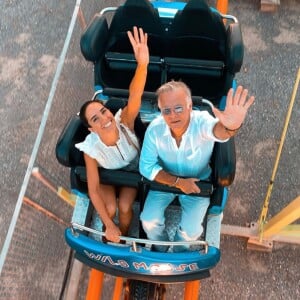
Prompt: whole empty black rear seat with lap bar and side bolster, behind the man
<box><xmin>166</xmin><ymin>0</ymin><xmax>243</xmax><ymax>105</ymax></box>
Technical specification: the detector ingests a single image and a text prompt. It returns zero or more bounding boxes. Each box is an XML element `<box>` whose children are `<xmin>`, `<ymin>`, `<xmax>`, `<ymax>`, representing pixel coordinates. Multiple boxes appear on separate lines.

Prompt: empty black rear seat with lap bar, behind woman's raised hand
<box><xmin>80</xmin><ymin>0</ymin><xmax>164</xmax><ymax>91</ymax></box>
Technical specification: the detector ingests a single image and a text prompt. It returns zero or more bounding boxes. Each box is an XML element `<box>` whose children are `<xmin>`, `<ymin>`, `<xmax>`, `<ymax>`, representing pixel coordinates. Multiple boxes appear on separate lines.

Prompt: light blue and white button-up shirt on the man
<box><xmin>140</xmin><ymin>111</ymin><xmax>227</xmax><ymax>180</ymax></box>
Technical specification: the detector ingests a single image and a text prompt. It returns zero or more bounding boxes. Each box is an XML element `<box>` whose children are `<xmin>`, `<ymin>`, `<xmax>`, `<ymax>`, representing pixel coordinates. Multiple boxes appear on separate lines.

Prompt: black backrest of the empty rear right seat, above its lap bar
<box><xmin>169</xmin><ymin>0</ymin><xmax>226</xmax><ymax>60</ymax></box>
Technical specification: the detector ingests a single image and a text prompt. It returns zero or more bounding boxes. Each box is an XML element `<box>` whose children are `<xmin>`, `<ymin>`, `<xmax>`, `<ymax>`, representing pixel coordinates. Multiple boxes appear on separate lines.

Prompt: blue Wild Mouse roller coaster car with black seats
<box><xmin>56</xmin><ymin>0</ymin><xmax>243</xmax><ymax>290</ymax></box>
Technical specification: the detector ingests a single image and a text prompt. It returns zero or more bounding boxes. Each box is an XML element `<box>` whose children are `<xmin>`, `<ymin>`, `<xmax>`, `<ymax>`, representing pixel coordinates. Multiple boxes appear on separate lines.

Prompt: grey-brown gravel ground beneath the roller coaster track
<box><xmin>0</xmin><ymin>0</ymin><xmax>300</xmax><ymax>300</ymax></box>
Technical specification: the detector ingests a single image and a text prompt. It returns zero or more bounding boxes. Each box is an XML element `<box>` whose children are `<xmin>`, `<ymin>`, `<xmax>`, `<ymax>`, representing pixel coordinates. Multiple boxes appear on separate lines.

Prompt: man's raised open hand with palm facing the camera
<box><xmin>213</xmin><ymin>86</ymin><xmax>254</xmax><ymax>130</ymax></box>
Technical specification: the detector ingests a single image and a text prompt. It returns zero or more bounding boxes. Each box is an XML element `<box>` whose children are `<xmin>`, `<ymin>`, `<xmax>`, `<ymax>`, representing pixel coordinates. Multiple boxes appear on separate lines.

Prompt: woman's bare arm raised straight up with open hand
<box><xmin>121</xmin><ymin>27</ymin><xmax>149</xmax><ymax>130</ymax></box>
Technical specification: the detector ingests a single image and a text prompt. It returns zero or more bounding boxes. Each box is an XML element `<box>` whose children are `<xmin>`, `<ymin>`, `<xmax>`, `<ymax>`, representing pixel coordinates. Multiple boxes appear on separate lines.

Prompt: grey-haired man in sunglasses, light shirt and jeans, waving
<box><xmin>140</xmin><ymin>81</ymin><xmax>254</xmax><ymax>252</ymax></box>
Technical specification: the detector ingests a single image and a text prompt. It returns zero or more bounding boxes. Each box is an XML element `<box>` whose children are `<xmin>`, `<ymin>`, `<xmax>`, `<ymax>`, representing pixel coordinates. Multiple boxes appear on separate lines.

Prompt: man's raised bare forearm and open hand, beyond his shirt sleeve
<box><xmin>213</xmin><ymin>86</ymin><xmax>254</xmax><ymax>140</ymax></box>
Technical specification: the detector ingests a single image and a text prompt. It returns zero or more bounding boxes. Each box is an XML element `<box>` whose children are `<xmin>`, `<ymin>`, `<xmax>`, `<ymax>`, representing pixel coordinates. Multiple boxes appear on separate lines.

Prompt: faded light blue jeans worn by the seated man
<box><xmin>140</xmin><ymin>190</ymin><xmax>210</xmax><ymax>252</ymax></box>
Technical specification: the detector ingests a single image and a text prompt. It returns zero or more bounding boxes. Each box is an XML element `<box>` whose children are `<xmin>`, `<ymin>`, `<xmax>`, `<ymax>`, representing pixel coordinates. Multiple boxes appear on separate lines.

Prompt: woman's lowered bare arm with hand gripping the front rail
<box><xmin>84</xmin><ymin>154</ymin><xmax>121</xmax><ymax>242</ymax></box>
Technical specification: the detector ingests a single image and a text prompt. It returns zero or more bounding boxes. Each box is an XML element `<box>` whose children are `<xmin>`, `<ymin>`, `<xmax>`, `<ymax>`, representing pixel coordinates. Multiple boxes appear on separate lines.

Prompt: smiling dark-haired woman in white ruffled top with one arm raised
<box><xmin>76</xmin><ymin>27</ymin><xmax>149</xmax><ymax>242</ymax></box>
